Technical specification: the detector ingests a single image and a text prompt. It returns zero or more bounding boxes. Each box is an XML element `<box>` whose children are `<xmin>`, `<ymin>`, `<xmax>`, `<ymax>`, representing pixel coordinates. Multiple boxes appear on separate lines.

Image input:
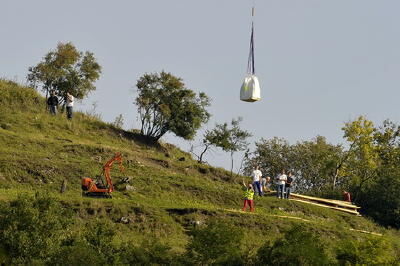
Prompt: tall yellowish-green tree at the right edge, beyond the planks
<box><xmin>343</xmin><ymin>116</ymin><xmax>400</xmax><ymax>228</ymax></box>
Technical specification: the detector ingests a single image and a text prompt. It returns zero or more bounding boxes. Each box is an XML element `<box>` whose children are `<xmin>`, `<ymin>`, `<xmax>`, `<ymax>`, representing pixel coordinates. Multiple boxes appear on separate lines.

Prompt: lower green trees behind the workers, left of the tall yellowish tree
<box><xmin>245</xmin><ymin>136</ymin><xmax>343</xmax><ymax>194</ymax></box>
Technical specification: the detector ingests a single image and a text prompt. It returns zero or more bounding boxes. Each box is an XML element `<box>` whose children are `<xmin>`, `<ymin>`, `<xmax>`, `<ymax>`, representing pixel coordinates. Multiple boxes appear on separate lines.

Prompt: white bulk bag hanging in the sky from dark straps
<box><xmin>240</xmin><ymin>7</ymin><xmax>261</xmax><ymax>102</ymax></box>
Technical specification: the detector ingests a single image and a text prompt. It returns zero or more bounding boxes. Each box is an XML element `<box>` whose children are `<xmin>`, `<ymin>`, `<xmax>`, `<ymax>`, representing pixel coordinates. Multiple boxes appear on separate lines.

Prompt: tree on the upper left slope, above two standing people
<box><xmin>27</xmin><ymin>42</ymin><xmax>101</xmax><ymax>104</ymax></box>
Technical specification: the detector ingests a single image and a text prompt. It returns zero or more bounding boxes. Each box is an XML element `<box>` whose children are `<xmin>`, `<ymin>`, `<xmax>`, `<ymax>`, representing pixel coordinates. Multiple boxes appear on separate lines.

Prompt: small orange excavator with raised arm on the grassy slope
<box><xmin>82</xmin><ymin>152</ymin><xmax>124</xmax><ymax>198</ymax></box>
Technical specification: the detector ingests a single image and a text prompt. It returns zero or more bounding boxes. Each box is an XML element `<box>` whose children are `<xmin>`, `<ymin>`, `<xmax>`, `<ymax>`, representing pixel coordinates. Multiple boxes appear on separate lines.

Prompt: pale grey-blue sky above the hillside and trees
<box><xmin>0</xmin><ymin>0</ymin><xmax>400</xmax><ymax>168</ymax></box>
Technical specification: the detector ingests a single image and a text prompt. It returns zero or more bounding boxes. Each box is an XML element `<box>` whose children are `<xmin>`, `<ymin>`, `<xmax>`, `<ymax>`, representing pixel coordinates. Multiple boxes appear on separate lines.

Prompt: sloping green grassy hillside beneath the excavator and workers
<box><xmin>0</xmin><ymin>80</ymin><xmax>400</xmax><ymax>264</ymax></box>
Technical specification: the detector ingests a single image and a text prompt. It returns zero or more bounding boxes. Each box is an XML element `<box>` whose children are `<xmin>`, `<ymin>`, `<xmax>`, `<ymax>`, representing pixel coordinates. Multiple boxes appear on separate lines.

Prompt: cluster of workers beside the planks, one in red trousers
<box><xmin>242</xmin><ymin>166</ymin><xmax>293</xmax><ymax>212</ymax></box>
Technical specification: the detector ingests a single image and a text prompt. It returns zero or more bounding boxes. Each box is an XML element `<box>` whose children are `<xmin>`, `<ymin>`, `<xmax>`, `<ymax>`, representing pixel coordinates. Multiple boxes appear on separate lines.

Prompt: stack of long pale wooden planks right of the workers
<box><xmin>290</xmin><ymin>193</ymin><xmax>361</xmax><ymax>216</ymax></box>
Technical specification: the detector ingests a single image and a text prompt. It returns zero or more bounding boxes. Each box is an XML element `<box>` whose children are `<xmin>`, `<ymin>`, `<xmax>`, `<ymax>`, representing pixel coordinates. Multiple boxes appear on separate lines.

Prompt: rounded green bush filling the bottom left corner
<box><xmin>0</xmin><ymin>194</ymin><xmax>72</xmax><ymax>264</ymax></box>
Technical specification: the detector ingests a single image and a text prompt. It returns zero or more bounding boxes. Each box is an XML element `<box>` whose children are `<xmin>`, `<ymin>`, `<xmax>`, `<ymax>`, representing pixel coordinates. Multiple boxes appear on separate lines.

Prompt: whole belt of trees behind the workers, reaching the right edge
<box><xmin>245</xmin><ymin>116</ymin><xmax>400</xmax><ymax>228</ymax></box>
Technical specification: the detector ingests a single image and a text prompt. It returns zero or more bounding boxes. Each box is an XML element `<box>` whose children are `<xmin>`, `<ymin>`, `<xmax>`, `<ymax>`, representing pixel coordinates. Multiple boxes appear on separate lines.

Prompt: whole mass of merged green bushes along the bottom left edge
<box><xmin>0</xmin><ymin>194</ymin><xmax>175</xmax><ymax>265</ymax></box>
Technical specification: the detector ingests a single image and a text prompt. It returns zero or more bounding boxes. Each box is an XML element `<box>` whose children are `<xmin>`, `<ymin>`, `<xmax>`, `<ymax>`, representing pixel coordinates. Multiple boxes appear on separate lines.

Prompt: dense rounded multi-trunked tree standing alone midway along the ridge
<box><xmin>135</xmin><ymin>71</ymin><xmax>210</xmax><ymax>141</ymax></box>
